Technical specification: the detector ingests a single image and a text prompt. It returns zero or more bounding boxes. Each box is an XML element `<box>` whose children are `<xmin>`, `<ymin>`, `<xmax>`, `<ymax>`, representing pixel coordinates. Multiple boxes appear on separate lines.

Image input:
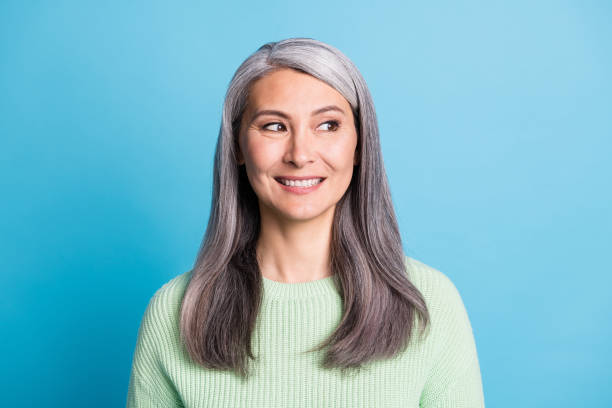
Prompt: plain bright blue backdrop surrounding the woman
<box><xmin>0</xmin><ymin>1</ymin><xmax>612</xmax><ymax>408</ymax></box>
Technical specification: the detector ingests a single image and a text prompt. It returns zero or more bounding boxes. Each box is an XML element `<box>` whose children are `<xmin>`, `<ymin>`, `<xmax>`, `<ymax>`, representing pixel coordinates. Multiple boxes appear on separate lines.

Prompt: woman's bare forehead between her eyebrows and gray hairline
<box><xmin>247</xmin><ymin>68</ymin><xmax>350</xmax><ymax>111</ymax></box>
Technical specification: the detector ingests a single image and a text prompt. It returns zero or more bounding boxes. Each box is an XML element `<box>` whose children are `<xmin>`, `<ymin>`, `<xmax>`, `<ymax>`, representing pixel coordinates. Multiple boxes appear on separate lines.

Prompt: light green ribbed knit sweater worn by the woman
<box><xmin>127</xmin><ymin>257</ymin><xmax>484</xmax><ymax>408</ymax></box>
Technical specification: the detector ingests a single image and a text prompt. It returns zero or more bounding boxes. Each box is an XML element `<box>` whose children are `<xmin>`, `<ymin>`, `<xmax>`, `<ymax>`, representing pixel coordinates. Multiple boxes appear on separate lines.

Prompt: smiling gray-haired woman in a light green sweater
<box><xmin>127</xmin><ymin>38</ymin><xmax>484</xmax><ymax>407</ymax></box>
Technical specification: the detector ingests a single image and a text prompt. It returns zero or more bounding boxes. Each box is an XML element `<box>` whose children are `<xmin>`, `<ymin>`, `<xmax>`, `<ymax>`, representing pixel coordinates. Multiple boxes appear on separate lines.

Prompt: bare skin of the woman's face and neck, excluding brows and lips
<box><xmin>237</xmin><ymin>68</ymin><xmax>358</xmax><ymax>283</ymax></box>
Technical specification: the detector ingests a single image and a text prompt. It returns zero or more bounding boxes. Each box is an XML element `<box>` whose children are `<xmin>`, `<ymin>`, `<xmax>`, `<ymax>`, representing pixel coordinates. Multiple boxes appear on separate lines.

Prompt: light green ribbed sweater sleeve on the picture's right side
<box><xmin>419</xmin><ymin>274</ymin><xmax>485</xmax><ymax>408</ymax></box>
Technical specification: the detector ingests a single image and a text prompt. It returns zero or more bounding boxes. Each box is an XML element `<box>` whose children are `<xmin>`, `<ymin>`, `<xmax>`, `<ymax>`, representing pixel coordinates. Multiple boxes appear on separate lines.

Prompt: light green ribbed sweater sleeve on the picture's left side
<box><xmin>126</xmin><ymin>292</ymin><xmax>183</xmax><ymax>408</ymax></box>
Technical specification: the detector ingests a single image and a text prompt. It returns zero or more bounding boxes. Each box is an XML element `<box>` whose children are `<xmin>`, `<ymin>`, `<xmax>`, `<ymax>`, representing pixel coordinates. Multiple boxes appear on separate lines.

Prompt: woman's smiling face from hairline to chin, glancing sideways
<box><xmin>238</xmin><ymin>68</ymin><xmax>358</xmax><ymax>225</ymax></box>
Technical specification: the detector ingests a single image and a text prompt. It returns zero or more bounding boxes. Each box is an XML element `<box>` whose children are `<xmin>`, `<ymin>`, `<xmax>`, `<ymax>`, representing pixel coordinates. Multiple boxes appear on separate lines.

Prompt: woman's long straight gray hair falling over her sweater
<box><xmin>180</xmin><ymin>38</ymin><xmax>430</xmax><ymax>377</ymax></box>
